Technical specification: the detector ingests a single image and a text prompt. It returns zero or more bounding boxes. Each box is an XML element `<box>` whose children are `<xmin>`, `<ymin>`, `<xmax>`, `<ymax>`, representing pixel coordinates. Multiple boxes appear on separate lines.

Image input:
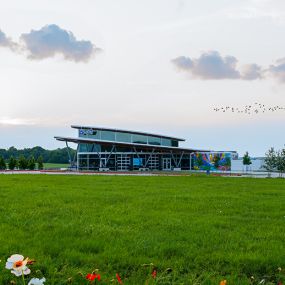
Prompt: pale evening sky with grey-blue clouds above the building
<box><xmin>0</xmin><ymin>0</ymin><xmax>285</xmax><ymax>156</ymax></box>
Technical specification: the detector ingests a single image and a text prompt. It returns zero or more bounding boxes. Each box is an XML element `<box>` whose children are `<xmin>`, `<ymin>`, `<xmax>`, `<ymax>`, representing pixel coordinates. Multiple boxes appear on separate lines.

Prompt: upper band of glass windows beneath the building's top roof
<box><xmin>79</xmin><ymin>129</ymin><xmax>178</xmax><ymax>146</ymax></box>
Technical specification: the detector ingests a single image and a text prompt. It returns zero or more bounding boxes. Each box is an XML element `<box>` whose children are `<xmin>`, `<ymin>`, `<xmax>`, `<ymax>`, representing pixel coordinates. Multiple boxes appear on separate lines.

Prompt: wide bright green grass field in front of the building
<box><xmin>0</xmin><ymin>175</ymin><xmax>285</xmax><ymax>285</ymax></box>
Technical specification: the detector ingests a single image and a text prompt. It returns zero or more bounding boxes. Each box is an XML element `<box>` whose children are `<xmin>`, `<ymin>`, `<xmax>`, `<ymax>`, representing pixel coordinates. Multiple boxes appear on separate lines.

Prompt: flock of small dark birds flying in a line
<box><xmin>214</xmin><ymin>102</ymin><xmax>285</xmax><ymax>115</ymax></box>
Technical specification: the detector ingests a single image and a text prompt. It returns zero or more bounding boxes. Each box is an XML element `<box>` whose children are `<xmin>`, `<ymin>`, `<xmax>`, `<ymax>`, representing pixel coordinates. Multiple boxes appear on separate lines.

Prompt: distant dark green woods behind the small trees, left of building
<box><xmin>0</xmin><ymin>146</ymin><xmax>76</xmax><ymax>163</ymax></box>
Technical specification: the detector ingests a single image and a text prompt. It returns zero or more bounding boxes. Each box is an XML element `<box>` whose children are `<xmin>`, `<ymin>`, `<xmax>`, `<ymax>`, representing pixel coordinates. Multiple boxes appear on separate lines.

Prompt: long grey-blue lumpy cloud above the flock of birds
<box><xmin>172</xmin><ymin>51</ymin><xmax>262</xmax><ymax>80</ymax></box>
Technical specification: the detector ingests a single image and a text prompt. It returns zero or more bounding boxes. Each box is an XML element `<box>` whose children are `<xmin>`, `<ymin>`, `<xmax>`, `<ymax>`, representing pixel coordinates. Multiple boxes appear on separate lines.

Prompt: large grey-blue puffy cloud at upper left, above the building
<box><xmin>21</xmin><ymin>25</ymin><xmax>100</xmax><ymax>62</ymax></box>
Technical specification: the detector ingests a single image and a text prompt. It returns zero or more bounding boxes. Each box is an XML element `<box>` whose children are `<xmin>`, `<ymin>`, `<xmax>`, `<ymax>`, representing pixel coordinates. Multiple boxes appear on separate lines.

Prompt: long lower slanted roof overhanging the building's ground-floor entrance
<box><xmin>54</xmin><ymin>136</ymin><xmax>206</xmax><ymax>153</ymax></box>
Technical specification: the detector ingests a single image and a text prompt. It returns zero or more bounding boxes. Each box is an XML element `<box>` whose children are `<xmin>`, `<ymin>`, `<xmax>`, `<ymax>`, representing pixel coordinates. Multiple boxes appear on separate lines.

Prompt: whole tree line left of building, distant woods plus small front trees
<box><xmin>0</xmin><ymin>146</ymin><xmax>76</xmax><ymax>169</ymax></box>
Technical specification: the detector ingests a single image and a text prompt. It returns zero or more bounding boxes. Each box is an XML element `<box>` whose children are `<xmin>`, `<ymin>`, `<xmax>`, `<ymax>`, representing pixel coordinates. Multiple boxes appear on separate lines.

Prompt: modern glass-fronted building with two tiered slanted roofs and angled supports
<box><xmin>55</xmin><ymin>125</ymin><xmax>235</xmax><ymax>171</ymax></box>
